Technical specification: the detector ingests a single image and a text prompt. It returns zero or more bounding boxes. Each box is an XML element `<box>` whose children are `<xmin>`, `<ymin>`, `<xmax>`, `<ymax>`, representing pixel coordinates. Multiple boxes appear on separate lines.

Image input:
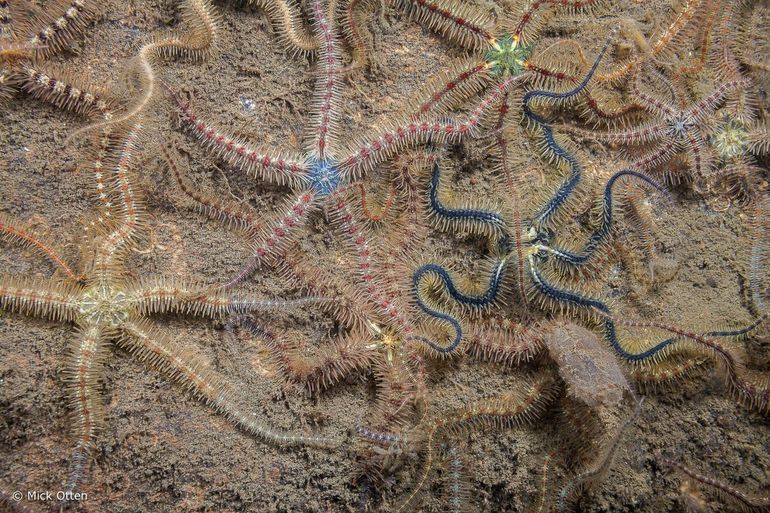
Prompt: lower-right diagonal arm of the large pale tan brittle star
<box><xmin>118</xmin><ymin>320</ymin><xmax>338</xmax><ymax>447</ymax></box>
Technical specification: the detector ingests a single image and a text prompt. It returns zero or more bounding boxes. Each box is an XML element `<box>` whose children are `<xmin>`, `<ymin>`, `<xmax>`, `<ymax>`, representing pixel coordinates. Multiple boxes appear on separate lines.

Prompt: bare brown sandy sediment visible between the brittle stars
<box><xmin>0</xmin><ymin>0</ymin><xmax>770</xmax><ymax>513</ymax></box>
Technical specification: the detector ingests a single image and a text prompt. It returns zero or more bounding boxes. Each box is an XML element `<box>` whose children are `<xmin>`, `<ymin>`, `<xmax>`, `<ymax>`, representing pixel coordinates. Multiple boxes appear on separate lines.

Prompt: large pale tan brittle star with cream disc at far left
<box><xmin>0</xmin><ymin>119</ymin><xmax>326</xmax><ymax>491</ymax></box>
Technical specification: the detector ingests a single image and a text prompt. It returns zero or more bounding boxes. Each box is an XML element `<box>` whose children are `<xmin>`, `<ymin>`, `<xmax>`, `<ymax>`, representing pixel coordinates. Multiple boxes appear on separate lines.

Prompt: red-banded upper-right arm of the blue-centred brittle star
<box><xmin>339</xmin><ymin>74</ymin><xmax>526</xmax><ymax>181</ymax></box>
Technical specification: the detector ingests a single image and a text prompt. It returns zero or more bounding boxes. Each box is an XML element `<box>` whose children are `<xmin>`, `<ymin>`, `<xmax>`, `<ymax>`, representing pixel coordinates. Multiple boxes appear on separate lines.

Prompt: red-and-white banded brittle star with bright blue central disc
<box><xmin>166</xmin><ymin>0</ymin><xmax>519</xmax><ymax>350</ymax></box>
